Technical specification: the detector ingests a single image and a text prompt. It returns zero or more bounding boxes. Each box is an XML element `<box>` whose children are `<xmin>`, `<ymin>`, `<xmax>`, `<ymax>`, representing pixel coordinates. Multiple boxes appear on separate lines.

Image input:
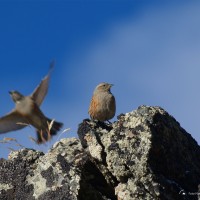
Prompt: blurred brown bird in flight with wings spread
<box><xmin>0</xmin><ymin>61</ymin><xmax>63</xmax><ymax>144</ymax></box>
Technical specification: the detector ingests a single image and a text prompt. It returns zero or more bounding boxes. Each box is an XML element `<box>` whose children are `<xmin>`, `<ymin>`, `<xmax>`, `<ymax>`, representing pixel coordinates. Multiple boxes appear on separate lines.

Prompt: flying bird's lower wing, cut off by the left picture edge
<box><xmin>0</xmin><ymin>110</ymin><xmax>28</xmax><ymax>133</ymax></box>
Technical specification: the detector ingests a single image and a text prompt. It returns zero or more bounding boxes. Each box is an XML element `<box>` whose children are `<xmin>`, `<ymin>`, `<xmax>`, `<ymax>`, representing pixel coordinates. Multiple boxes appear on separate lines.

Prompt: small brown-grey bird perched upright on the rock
<box><xmin>88</xmin><ymin>83</ymin><xmax>116</xmax><ymax>122</ymax></box>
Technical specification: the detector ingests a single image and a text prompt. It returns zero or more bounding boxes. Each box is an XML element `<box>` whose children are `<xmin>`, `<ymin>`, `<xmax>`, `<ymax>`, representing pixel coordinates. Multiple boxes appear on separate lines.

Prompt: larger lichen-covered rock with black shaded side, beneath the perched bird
<box><xmin>79</xmin><ymin>106</ymin><xmax>200</xmax><ymax>200</ymax></box>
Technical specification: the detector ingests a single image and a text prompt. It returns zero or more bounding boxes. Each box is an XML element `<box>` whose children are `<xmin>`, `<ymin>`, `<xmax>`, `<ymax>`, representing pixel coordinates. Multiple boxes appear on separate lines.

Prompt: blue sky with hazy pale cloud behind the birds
<box><xmin>0</xmin><ymin>0</ymin><xmax>200</xmax><ymax>158</ymax></box>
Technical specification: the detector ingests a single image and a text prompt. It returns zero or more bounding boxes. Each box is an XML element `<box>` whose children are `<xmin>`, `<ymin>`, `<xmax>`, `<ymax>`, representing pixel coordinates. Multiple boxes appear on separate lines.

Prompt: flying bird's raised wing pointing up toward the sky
<box><xmin>31</xmin><ymin>61</ymin><xmax>55</xmax><ymax>106</ymax></box>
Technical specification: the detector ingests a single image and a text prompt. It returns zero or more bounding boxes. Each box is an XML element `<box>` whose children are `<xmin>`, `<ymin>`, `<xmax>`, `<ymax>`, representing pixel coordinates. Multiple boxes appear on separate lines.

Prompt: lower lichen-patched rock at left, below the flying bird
<box><xmin>0</xmin><ymin>138</ymin><xmax>87</xmax><ymax>200</ymax></box>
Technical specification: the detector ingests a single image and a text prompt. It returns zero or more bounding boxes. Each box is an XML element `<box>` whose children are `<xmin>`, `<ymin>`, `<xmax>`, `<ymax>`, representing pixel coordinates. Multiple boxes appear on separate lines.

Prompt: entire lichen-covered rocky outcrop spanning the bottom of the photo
<box><xmin>0</xmin><ymin>106</ymin><xmax>200</xmax><ymax>200</ymax></box>
